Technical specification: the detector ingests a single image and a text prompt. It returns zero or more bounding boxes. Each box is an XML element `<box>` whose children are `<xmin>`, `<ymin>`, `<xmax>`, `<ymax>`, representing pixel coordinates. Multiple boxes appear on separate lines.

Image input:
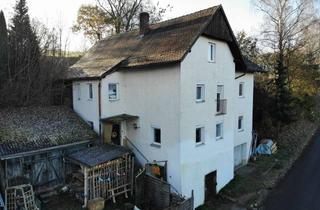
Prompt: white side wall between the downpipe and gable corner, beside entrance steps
<box><xmin>101</xmin><ymin>65</ymin><xmax>181</xmax><ymax>189</ymax></box>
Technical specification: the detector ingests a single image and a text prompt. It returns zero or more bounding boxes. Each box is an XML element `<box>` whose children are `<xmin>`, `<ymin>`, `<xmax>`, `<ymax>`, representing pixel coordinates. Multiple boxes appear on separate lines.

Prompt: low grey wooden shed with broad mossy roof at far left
<box><xmin>0</xmin><ymin>106</ymin><xmax>97</xmax><ymax>208</ymax></box>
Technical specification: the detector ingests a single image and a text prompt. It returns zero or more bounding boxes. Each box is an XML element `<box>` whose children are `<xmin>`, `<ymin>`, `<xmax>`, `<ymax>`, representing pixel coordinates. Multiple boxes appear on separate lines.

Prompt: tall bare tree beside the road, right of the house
<box><xmin>256</xmin><ymin>0</ymin><xmax>316</xmax><ymax>121</ymax></box>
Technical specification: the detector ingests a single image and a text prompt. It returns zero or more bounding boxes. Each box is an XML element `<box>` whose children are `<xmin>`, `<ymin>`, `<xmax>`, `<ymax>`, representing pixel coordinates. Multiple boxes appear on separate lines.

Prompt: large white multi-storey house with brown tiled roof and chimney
<box><xmin>65</xmin><ymin>5</ymin><xmax>261</xmax><ymax>207</ymax></box>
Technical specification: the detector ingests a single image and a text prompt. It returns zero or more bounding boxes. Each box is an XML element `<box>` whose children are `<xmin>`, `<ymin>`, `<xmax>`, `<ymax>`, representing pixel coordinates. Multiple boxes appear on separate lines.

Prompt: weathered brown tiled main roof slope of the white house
<box><xmin>65</xmin><ymin>6</ymin><xmax>221</xmax><ymax>79</ymax></box>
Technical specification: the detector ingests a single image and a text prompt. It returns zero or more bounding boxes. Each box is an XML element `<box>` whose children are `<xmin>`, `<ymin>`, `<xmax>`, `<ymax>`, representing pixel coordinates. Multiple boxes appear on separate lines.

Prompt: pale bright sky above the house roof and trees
<box><xmin>0</xmin><ymin>0</ymin><xmax>263</xmax><ymax>51</ymax></box>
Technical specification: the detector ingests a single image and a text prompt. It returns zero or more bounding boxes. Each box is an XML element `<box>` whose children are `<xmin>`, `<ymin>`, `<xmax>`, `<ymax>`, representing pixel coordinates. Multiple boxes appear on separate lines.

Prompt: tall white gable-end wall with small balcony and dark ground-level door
<box><xmin>180</xmin><ymin>37</ymin><xmax>235</xmax><ymax>207</ymax></box>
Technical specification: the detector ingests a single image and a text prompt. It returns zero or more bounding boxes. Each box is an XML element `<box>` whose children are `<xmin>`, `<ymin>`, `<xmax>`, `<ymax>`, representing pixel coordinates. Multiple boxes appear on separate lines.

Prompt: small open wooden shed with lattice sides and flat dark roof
<box><xmin>67</xmin><ymin>144</ymin><xmax>134</xmax><ymax>207</ymax></box>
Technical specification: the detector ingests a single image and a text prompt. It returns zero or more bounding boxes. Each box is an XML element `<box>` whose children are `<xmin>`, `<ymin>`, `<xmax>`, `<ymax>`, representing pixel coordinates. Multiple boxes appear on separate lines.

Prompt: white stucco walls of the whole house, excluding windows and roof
<box><xmin>73</xmin><ymin>36</ymin><xmax>253</xmax><ymax>207</ymax></box>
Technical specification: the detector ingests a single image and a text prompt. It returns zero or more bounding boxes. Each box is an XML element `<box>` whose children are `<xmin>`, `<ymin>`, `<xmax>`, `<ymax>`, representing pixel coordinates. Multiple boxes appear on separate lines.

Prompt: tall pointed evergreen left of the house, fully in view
<box><xmin>9</xmin><ymin>0</ymin><xmax>41</xmax><ymax>104</ymax></box>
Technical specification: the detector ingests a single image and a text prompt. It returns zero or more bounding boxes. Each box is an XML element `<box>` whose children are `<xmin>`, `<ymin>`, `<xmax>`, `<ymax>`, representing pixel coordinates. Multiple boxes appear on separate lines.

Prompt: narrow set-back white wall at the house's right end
<box><xmin>234</xmin><ymin>73</ymin><xmax>254</xmax><ymax>166</ymax></box>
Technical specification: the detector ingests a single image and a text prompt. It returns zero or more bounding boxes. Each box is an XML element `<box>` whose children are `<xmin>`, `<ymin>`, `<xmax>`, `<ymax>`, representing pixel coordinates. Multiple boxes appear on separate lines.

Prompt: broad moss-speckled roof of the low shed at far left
<box><xmin>0</xmin><ymin>106</ymin><xmax>96</xmax><ymax>157</ymax></box>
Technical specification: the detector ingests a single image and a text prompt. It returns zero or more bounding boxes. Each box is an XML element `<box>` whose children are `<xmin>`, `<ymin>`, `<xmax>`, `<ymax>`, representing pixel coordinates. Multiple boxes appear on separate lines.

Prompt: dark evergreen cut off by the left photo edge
<box><xmin>0</xmin><ymin>11</ymin><xmax>8</xmax><ymax>88</ymax></box>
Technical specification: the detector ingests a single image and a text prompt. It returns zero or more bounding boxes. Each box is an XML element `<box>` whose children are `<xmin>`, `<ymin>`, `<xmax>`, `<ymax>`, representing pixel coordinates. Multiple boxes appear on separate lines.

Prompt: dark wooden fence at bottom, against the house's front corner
<box><xmin>135</xmin><ymin>173</ymin><xmax>193</xmax><ymax>210</ymax></box>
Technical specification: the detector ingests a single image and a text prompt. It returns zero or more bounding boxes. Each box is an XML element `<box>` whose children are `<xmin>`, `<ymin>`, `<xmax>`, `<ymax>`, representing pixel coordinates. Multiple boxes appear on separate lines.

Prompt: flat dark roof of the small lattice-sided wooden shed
<box><xmin>67</xmin><ymin>144</ymin><xmax>131</xmax><ymax>168</ymax></box>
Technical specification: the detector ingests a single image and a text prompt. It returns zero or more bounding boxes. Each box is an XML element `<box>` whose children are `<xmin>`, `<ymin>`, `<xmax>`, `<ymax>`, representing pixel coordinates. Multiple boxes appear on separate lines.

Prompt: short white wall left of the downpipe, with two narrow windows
<box><xmin>72</xmin><ymin>81</ymin><xmax>99</xmax><ymax>133</ymax></box>
